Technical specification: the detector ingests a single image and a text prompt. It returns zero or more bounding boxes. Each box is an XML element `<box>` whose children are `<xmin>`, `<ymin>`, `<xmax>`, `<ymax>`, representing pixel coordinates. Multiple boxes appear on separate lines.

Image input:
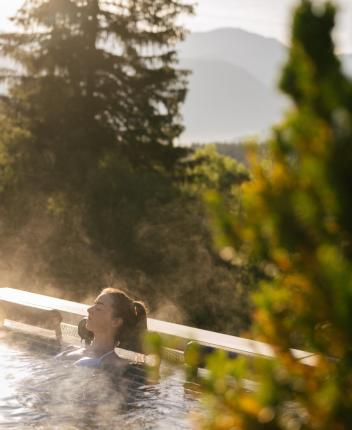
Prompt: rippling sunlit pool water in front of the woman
<box><xmin>0</xmin><ymin>337</ymin><xmax>197</xmax><ymax>430</ymax></box>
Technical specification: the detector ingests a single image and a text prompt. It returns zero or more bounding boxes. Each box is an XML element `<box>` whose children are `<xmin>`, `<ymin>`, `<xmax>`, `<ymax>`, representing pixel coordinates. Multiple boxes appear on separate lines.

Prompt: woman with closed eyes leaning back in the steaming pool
<box><xmin>58</xmin><ymin>288</ymin><xmax>147</xmax><ymax>368</ymax></box>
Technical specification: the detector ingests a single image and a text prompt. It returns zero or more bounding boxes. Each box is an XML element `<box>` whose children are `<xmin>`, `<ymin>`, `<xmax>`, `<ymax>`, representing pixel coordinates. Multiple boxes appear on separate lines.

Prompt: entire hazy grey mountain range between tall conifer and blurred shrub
<box><xmin>178</xmin><ymin>29</ymin><xmax>287</xmax><ymax>143</ymax></box>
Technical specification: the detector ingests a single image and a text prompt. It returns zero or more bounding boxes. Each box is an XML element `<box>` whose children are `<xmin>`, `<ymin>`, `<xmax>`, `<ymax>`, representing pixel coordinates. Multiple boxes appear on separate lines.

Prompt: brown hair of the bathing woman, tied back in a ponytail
<box><xmin>101</xmin><ymin>288</ymin><xmax>147</xmax><ymax>352</ymax></box>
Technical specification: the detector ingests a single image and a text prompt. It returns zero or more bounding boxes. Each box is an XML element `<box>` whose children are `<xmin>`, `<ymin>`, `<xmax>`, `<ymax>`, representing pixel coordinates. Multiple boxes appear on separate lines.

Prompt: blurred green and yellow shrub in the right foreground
<box><xmin>202</xmin><ymin>0</ymin><xmax>352</xmax><ymax>430</ymax></box>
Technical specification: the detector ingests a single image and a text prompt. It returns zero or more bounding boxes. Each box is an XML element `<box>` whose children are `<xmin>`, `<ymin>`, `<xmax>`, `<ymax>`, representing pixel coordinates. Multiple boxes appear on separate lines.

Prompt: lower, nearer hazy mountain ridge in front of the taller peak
<box><xmin>181</xmin><ymin>59</ymin><xmax>282</xmax><ymax>143</ymax></box>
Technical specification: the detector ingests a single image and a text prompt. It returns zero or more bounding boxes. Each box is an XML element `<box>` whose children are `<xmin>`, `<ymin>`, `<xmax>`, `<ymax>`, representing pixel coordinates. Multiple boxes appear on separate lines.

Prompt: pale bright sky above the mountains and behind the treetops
<box><xmin>0</xmin><ymin>0</ymin><xmax>352</xmax><ymax>52</ymax></box>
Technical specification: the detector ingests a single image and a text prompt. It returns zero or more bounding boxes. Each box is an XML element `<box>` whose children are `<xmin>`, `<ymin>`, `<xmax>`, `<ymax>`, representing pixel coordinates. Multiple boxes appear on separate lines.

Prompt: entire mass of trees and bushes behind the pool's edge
<box><xmin>0</xmin><ymin>0</ymin><xmax>251</xmax><ymax>334</ymax></box>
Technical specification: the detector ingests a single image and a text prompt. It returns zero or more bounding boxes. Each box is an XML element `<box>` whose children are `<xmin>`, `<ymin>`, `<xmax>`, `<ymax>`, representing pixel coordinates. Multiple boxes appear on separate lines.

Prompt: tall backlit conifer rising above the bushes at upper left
<box><xmin>1</xmin><ymin>0</ymin><xmax>191</xmax><ymax>196</ymax></box>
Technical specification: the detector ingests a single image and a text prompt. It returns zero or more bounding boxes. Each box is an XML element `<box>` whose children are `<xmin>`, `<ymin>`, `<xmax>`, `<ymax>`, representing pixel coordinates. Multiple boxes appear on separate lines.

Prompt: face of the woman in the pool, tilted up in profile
<box><xmin>86</xmin><ymin>293</ymin><xmax>122</xmax><ymax>335</ymax></box>
